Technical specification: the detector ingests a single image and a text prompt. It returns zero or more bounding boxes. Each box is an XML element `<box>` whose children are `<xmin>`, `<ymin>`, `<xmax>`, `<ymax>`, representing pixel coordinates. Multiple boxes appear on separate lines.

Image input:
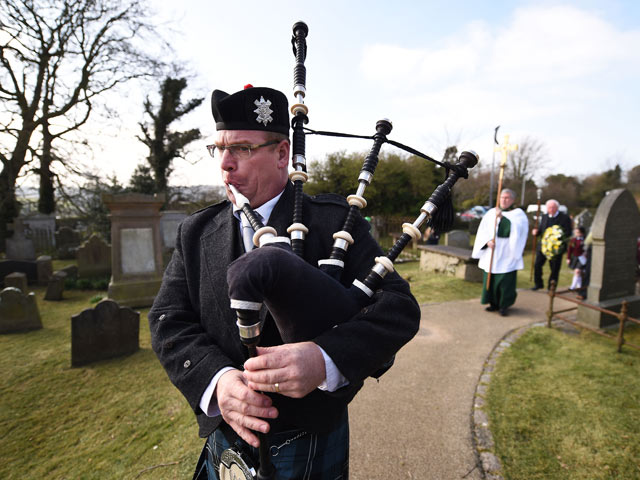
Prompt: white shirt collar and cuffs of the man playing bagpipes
<box><xmin>200</xmin><ymin>190</ymin><xmax>349</xmax><ymax>417</ymax></box>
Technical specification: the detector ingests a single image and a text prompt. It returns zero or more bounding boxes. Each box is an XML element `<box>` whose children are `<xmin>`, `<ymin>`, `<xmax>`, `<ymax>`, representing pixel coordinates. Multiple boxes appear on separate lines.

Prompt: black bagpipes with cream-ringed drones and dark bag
<box><xmin>220</xmin><ymin>22</ymin><xmax>478</xmax><ymax>479</ymax></box>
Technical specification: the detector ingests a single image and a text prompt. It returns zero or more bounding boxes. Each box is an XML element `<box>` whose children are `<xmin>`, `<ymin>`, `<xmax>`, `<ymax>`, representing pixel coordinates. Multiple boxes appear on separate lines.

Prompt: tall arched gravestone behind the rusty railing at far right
<box><xmin>578</xmin><ymin>189</ymin><xmax>640</xmax><ymax>328</ymax></box>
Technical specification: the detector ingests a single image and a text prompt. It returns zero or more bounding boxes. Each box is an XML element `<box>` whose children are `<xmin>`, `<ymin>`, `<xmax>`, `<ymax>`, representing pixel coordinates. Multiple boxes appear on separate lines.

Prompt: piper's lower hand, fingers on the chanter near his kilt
<box><xmin>216</xmin><ymin>370</ymin><xmax>278</xmax><ymax>448</ymax></box>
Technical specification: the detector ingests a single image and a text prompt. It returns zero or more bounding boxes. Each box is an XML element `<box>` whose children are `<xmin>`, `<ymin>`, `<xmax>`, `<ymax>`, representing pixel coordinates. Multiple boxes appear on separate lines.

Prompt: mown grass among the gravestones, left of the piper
<box><xmin>0</xmin><ymin>289</ymin><xmax>203</xmax><ymax>479</ymax></box>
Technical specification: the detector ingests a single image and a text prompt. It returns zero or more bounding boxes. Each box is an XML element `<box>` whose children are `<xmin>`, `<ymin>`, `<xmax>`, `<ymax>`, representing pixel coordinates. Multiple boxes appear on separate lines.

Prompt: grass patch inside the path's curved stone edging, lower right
<box><xmin>486</xmin><ymin>327</ymin><xmax>640</xmax><ymax>480</ymax></box>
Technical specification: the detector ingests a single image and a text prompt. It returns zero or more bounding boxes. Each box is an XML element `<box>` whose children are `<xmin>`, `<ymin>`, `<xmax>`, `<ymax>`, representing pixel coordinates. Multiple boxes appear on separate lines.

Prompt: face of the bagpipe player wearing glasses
<box><xmin>215</xmin><ymin>130</ymin><xmax>289</xmax><ymax>208</ymax></box>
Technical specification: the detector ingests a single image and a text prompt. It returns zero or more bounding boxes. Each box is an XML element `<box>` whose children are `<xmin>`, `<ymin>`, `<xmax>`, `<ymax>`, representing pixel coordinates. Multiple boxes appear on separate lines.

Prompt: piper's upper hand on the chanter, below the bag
<box><xmin>244</xmin><ymin>342</ymin><xmax>326</xmax><ymax>398</ymax></box>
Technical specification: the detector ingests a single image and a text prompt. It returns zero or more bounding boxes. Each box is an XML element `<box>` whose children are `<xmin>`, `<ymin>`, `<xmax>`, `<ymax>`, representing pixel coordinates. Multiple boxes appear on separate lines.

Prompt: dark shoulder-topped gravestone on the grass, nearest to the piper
<box><xmin>71</xmin><ymin>299</ymin><xmax>140</xmax><ymax>367</ymax></box>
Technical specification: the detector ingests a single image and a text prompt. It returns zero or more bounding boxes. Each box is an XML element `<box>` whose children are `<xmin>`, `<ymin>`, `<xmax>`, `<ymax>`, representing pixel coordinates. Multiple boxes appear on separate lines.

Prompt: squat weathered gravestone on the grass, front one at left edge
<box><xmin>0</xmin><ymin>287</ymin><xmax>42</xmax><ymax>333</ymax></box>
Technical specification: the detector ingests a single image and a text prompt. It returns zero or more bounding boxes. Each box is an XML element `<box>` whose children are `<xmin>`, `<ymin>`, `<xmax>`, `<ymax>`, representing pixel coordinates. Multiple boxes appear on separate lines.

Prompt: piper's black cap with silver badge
<box><xmin>211</xmin><ymin>85</ymin><xmax>289</xmax><ymax>136</ymax></box>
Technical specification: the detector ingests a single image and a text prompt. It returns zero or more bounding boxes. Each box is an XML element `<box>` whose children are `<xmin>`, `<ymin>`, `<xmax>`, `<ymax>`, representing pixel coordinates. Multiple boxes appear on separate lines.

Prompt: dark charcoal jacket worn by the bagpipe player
<box><xmin>149</xmin><ymin>183</ymin><xmax>420</xmax><ymax>437</ymax></box>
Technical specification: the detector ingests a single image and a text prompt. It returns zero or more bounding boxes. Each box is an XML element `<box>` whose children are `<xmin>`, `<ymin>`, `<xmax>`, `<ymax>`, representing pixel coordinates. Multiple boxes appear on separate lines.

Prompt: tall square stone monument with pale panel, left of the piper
<box><xmin>102</xmin><ymin>193</ymin><xmax>164</xmax><ymax>307</ymax></box>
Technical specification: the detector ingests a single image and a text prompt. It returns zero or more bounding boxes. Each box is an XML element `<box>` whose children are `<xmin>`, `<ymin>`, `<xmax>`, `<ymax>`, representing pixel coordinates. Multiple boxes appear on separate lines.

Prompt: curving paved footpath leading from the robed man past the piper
<box><xmin>349</xmin><ymin>290</ymin><xmax>572</xmax><ymax>480</ymax></box>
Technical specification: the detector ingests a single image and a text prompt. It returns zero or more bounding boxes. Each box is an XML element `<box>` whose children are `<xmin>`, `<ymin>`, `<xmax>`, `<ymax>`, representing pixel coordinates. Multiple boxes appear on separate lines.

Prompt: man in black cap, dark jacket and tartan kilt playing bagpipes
<box><xmin>149</xmin><ymin>84</ymin><xmax>420</xmax><ymax>479</ymax></box>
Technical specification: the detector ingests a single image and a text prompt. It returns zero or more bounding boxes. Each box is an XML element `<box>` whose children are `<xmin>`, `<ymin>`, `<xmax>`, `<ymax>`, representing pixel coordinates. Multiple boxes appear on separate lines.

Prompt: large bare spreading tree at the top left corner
<box><xmin>0</xmin><ymin>0</ymin><xmax>165</xmax><ymax>247</ymax></box>
